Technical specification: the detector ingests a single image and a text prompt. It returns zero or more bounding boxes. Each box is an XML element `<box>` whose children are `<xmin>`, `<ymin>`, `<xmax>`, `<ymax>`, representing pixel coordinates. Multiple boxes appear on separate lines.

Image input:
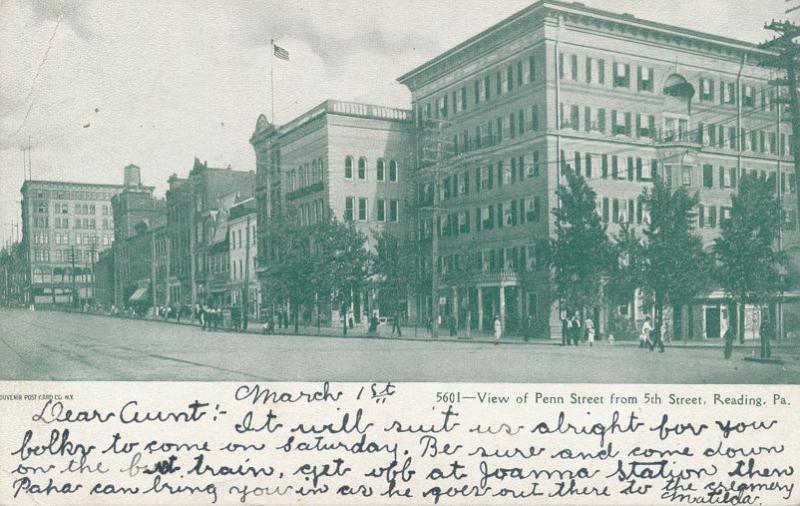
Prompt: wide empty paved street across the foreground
<box><xmin>0</xmin><ymin>309</ymin><xmax>800</xmax><ymax>384</ymax></box>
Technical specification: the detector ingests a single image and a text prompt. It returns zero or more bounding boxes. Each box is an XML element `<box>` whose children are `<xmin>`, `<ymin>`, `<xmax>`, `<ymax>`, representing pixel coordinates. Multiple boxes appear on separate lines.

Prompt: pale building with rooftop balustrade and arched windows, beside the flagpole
<box><xmin>250</xmin><ymin>100</ymin><xmax>414</xmax><ymax>320</ymax></box>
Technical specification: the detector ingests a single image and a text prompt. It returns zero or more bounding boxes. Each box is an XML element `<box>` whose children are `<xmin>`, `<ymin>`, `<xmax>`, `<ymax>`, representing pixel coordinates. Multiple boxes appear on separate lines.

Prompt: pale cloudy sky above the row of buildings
<box><xmin>0</xmin><ymin>0</ymin><xmax>797</xmax><ymax>244</ymax></box>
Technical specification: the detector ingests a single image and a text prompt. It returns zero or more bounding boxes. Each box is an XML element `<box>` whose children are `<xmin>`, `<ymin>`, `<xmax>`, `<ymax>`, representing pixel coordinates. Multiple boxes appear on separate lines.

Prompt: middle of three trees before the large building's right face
<box><xmin>642</xmin><ymin>178</ymin><xmax>713</xmax><ymax>338</ymax></box>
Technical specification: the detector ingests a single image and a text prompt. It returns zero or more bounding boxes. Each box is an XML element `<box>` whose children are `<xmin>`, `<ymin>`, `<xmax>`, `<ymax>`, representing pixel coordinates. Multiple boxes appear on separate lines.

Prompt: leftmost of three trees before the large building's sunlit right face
<box><xmin>550</xmin><ymin>169</ymin><xmax>612</xmax><ymax>309</ymax></box>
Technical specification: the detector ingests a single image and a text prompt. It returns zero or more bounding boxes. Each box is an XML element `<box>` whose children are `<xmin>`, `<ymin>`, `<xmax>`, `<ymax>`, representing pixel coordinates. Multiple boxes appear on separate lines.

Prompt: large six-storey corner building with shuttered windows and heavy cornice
<box><xmin>399</xmin><ymin>0</ymin><xmax>798</xmax><ymax>339</ymax></box>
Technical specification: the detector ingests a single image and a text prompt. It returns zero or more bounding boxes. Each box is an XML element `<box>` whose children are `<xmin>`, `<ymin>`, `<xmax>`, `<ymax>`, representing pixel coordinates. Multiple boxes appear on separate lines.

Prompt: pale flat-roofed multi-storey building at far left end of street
<box><xmin>21</xmin><ymin>180</ymin><xmax>122</xmax><ymax>306</ymax></box>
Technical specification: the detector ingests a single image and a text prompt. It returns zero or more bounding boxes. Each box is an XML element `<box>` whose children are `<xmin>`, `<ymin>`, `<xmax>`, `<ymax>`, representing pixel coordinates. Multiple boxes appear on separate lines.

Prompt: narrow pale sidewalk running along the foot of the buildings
<box><xmin>48</xmin><ymin>310</ymin><xmax>800</xmax><ymax>354</ymax></box>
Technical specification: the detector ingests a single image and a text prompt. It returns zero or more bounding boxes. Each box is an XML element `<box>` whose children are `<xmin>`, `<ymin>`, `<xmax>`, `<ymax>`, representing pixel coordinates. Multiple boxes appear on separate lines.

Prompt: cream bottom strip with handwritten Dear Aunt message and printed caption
<box><xmin>0</xmin><ymin>383</ymin><xmax>800</xmax><ymax>505</ymax></box>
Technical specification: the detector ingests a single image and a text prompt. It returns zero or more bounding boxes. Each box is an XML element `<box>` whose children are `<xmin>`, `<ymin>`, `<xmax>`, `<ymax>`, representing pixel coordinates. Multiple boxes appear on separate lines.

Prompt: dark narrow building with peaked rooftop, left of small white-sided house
<box><xmin>167</xmin><ymin>159</ymin><xmax>255</xmax><ymax>306</ymax></box>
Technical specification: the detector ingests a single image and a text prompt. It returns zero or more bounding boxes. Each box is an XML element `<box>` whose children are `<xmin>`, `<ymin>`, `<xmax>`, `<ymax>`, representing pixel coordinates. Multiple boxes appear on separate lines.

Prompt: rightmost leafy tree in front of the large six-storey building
<box><xmin>714</xmin><ymin>175</ymin><xmax>785</xmax><ymax>350</ymax></box>
